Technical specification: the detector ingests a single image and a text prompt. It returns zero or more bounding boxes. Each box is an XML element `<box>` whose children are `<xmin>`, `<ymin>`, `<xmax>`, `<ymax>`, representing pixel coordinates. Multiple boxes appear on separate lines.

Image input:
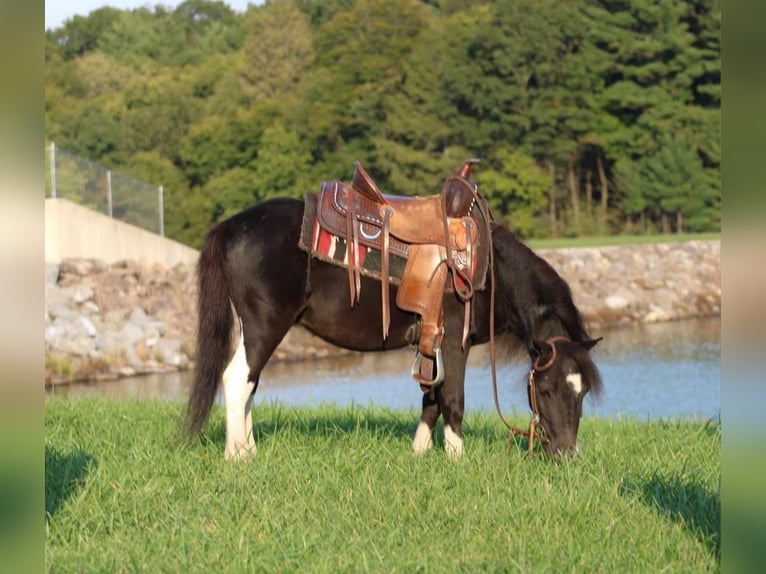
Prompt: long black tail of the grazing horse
<box><xmin>186</xmin><ymin>223</ymin><xmax>234</xmax><ymax>438</ymax></box>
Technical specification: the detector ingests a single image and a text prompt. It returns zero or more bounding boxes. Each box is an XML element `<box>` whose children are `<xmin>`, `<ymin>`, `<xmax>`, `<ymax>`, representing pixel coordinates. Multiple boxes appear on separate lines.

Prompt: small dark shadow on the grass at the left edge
<box><xmin>45</xmin><ymin>446</ymin><xmax>96</xmax><ymax>516</ymax></box>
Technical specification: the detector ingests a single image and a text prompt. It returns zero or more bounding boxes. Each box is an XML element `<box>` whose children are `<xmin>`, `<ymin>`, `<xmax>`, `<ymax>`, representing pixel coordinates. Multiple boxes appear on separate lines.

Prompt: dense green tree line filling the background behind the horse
<box><xmin>45</xmin><ymin>0</ymin><xmax>721</xmax><ymax>246</ymax></box>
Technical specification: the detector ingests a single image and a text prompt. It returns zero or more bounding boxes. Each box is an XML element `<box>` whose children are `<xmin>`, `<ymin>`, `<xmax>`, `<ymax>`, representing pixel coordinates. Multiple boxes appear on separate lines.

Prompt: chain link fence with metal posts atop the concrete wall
<box><xmin>45</xmin><ymin>143</ymin><xmax>165</xmax><ymax>236</ymax></box>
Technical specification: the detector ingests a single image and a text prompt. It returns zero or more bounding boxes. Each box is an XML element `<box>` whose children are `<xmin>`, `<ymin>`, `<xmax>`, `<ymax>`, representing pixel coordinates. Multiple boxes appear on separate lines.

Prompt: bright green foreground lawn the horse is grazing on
<box><xmin>45</xmin><ymin>398</ymin><xmax>720</xmax><ymax>573</ymax></box>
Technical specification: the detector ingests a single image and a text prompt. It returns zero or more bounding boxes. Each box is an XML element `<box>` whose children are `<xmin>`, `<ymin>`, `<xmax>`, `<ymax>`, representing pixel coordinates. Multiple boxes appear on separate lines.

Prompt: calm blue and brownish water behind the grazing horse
<box><xmin>49</xmin><ymin>319</ymin><xmax>721</xmax><ymax>419</ymax></box>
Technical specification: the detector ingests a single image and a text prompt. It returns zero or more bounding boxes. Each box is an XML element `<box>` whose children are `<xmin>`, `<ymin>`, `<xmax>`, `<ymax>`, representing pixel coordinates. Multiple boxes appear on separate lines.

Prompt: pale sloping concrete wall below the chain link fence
<box><xmin>45</xmin><ymin>198</ymin><xmax>199</xmax><ymax>266</ymax></box>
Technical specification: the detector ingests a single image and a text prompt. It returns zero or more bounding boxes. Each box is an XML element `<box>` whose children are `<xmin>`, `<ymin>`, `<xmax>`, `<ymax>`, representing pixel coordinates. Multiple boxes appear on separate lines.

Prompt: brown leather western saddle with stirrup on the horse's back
<box><xmin>306</xmin><ymin>159</ymin><xmax>491</xmax><ymax>390</ymax></box>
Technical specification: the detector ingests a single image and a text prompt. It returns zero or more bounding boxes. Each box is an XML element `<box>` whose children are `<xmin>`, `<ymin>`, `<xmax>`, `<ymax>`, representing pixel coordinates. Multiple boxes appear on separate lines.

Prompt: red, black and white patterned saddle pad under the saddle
<box><xmin>298</xmin><ymin>193</ymin><xmax>407</xmax><ymax>285</ymax></box>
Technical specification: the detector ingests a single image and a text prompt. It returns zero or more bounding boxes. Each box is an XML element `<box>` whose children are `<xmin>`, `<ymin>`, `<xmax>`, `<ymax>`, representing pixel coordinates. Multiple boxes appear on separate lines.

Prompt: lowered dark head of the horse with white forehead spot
<box><xmin>527</xmin><ymin>337</ymin><xmax>601</xmax><ymax>455</ymax></box>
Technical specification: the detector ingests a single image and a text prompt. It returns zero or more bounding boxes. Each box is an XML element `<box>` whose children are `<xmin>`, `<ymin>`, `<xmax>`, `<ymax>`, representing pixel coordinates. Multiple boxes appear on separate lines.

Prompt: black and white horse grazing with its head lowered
<box><xmin>187</xmin><ymin>198</ymin><xmax>601</xmax><ymax>458</ymax></box>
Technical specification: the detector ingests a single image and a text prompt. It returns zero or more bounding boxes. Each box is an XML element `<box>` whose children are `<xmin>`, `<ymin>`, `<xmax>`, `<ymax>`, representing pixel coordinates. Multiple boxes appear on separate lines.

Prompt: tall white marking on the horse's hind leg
<box><xmin>223</xmin><ymin>334</ymin><xmax>255</xmax><ymax>460</ymax></box>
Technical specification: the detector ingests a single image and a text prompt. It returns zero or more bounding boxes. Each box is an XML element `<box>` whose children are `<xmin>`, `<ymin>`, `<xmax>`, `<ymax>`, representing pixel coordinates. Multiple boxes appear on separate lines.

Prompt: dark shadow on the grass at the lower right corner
<box><xmin>620</xmin><ymin>474</ymin><xmax>721</xmax><ymax>563</ymax></box>
